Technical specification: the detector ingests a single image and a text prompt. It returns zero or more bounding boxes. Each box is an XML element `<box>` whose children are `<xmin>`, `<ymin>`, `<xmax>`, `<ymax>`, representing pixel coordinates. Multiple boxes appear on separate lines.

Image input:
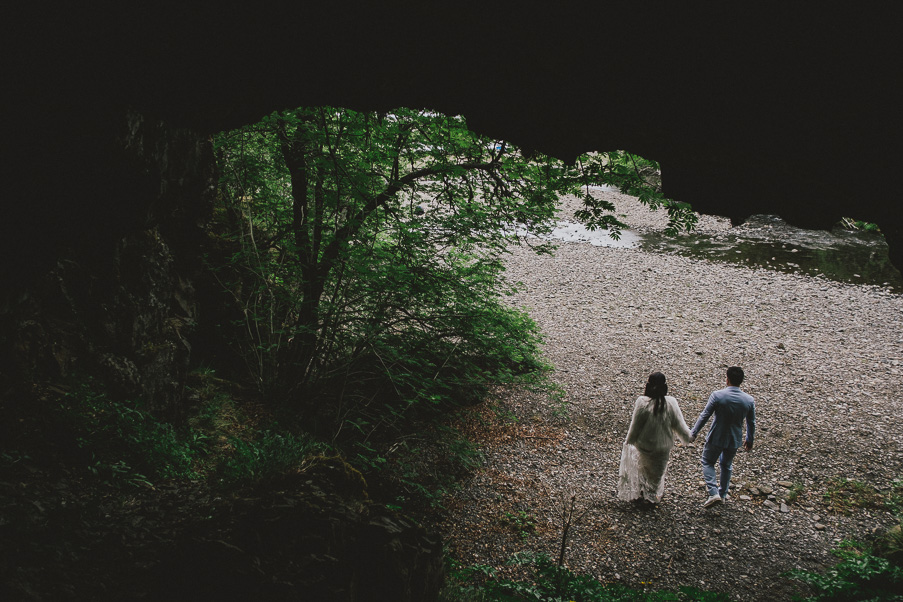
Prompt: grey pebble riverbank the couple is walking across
<box><xmin>443</xmin><ymin>186</ymin><xmax>903</xmax><ymax>600</ymax></box>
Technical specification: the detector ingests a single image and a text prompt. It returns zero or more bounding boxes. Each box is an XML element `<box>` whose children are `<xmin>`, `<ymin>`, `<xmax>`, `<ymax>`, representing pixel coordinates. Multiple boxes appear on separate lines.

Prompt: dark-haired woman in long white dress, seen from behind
<box><xmin>618</xmin><ymin>372</ymin><xmax>694</xmax><ymax>504</ymax></box>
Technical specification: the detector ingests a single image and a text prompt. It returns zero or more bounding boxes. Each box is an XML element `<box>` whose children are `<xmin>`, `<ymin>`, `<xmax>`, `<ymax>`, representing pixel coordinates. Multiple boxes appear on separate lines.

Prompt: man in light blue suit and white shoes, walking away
<box><xmin>690</xmin><ymin>366</ymin><xmax>756</xmax><ymax>508</ymax></box>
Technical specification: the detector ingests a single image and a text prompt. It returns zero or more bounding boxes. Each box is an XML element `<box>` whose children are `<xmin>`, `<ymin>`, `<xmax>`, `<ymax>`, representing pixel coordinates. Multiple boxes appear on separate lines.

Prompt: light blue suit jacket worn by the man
<box><xmin>690</xmin><ymin>386</ymin><xmax>756</xmax><ymax>449</ymax></box>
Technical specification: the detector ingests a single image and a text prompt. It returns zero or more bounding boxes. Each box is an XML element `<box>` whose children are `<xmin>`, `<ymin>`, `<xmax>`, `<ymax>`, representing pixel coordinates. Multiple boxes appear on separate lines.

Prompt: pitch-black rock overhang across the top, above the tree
<box><xmin>2</xmin><ymin>0</ymin><xmax>903</xmax><ymax>274</ymax></box>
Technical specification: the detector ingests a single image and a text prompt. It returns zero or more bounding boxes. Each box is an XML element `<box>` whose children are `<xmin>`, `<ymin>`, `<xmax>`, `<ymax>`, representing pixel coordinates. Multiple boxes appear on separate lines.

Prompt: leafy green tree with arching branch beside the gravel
<box><xmin>216</xmin><ymin>107</ymin><xmax>690</xmax><ymax>426</ymax></box>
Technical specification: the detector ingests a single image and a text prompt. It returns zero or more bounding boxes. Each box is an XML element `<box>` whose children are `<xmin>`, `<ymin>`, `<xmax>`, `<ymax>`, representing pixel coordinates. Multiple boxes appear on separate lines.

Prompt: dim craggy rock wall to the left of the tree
<box><xmin>0</xmin><ymin>112</ymin><xmax>213</xmax><ymax>420</ymax></box>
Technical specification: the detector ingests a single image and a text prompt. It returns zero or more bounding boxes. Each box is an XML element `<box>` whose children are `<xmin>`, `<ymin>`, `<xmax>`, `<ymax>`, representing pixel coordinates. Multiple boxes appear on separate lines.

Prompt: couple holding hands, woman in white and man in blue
<box><xmin>618</xmin><ymin>366</ymin><xmax>756</xmax><ymax>508</ymax></box>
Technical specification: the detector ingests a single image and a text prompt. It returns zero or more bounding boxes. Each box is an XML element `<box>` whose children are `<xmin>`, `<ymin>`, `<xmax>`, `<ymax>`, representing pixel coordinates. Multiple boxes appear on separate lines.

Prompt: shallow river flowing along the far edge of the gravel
<box><xmin>532</xmin><ymin>215</ymin><xmax>903</xmax><ymax>294</ymax></box>
